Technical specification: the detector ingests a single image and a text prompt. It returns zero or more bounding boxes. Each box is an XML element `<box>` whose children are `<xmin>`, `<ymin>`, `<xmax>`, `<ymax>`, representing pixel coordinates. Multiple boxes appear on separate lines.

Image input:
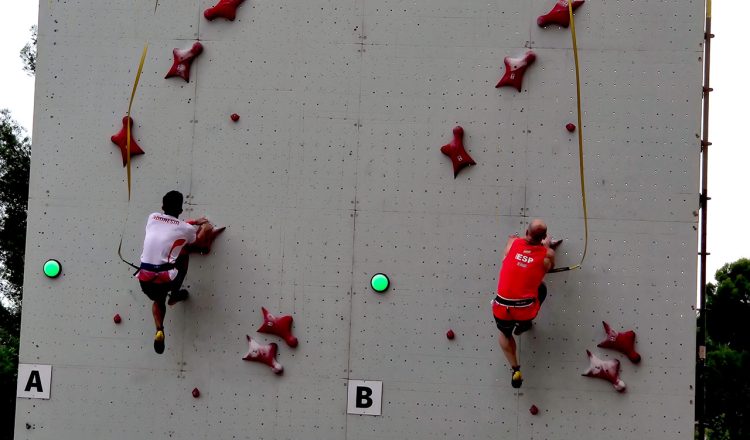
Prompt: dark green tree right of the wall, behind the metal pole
<box><xmin>705</xmin><ymin>258</ymin><xmax>750</xmax><ymax>440</ymax></box>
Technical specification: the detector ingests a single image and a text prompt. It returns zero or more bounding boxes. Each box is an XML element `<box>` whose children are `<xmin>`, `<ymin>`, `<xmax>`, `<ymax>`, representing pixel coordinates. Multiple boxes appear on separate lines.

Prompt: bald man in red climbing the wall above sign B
<box><xmin>492</xmin><ymin>219</ymin><xmax>562</xmax><ymax>388</ymax></box>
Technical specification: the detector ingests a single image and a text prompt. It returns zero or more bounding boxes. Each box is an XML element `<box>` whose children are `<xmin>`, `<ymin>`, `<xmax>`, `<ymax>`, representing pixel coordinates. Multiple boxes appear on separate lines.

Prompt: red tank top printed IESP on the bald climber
<box><xmin>497</xmin><ymin>238</ymin><xmax>547</xmax><ymax>299</ymax></box>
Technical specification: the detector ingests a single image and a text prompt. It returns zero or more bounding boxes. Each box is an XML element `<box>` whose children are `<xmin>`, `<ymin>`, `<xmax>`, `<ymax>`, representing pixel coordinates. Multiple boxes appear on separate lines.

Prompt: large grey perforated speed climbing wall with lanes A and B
<box><xmin>16</xmin><ymin>0</ymin><xmax>703</xmax><ymax>440</ymax></box>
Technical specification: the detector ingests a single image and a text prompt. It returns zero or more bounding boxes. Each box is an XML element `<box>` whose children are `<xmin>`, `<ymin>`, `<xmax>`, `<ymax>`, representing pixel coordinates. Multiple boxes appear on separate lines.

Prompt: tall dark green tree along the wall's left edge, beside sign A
<box><xmin>0</xmin><ymin>110</ymin><xmax>31</xmax><ymax>438</ymax></box>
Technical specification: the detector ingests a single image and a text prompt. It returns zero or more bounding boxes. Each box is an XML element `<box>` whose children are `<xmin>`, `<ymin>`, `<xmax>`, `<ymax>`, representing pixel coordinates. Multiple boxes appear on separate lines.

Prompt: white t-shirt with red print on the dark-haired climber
<box><xmin>141</xmin><ymin>212</ymin><xmax>198</xmax><ymax>279</ymax></box>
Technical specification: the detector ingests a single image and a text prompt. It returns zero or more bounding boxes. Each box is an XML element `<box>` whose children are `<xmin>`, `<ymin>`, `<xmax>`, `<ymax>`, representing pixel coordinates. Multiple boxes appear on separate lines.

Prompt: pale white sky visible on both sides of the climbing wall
<box><xmin>0</xmin><ymin>0</ymin><xmax>750</xmax><ymax>280</ymax></box>
